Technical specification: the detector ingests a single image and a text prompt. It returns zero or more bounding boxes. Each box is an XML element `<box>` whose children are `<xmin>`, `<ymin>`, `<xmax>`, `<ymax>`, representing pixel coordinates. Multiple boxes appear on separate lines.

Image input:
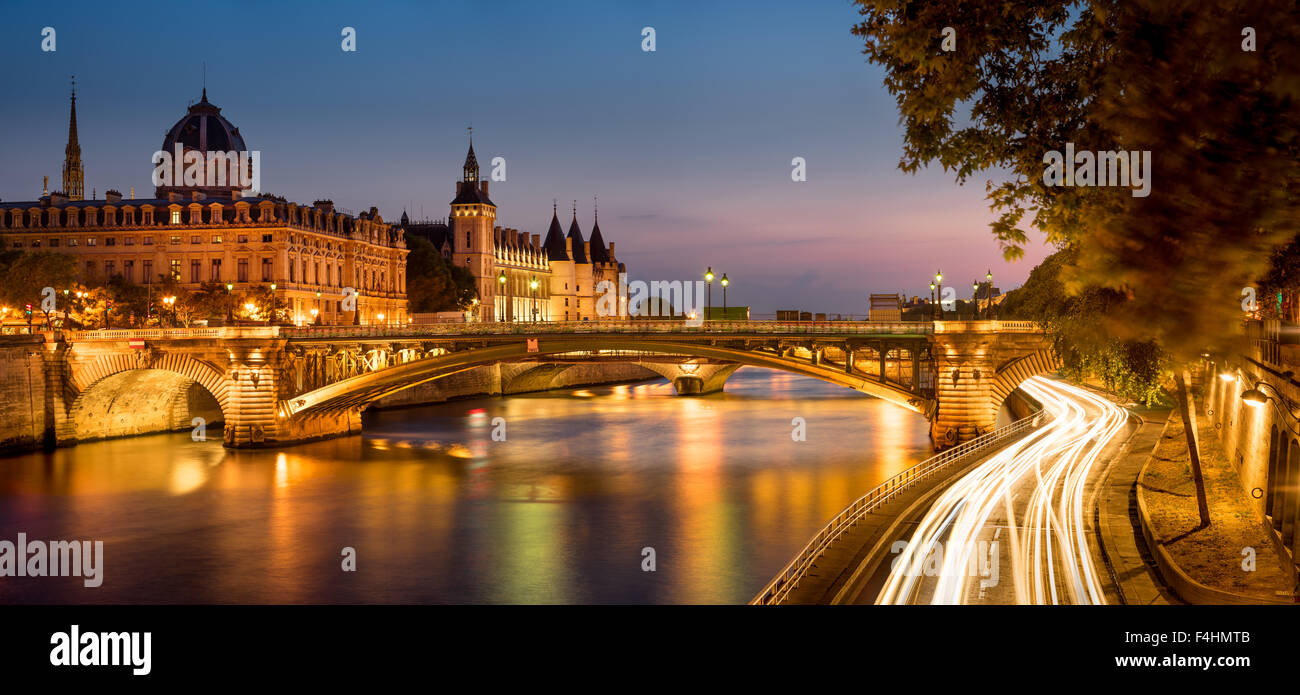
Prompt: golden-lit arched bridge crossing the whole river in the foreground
<box><xmin>12</xmin><ymin>321</ymin><xmax>1057</xmax><ymax>448</ymax></box>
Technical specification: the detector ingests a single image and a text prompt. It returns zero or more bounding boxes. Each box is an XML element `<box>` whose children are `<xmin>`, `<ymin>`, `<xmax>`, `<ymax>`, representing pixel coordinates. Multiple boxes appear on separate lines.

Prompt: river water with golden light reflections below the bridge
<box><xmin>0</xmin><ymin>368</ymin><xmax>928</xmax><ymax>603</ymax></box>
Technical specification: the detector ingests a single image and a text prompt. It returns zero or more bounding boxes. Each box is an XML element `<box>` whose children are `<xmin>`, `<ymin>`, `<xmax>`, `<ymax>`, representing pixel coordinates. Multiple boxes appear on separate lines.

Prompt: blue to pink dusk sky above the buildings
<box><xmin>0</xmin><ymin>0</ymin><xmax>1049</xmax><ymax>314</ymax></box>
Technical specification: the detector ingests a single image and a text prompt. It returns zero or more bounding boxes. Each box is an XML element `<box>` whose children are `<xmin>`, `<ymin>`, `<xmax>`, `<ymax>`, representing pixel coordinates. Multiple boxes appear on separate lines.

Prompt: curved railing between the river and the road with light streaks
<box><xmin>749</xmin><ymin>412</ymin><xmax>1050</xmax><ymax>605</ymax></box>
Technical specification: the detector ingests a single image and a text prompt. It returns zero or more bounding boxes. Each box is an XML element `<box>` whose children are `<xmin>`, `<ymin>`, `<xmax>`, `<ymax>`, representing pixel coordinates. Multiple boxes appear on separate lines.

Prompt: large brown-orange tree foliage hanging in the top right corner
<box><xmin>854</xmin><ymin>0</ymin><xmax>1300</xmax><ymax>360</ymax></box>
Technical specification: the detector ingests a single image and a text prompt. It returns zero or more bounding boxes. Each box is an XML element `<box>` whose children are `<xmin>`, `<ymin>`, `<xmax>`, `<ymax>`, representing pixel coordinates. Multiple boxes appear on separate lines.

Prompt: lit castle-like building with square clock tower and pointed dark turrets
<box><xmin>402</xmin><ymin>142</ymin><xmax>627</xmax><ymax>326</ymax></box>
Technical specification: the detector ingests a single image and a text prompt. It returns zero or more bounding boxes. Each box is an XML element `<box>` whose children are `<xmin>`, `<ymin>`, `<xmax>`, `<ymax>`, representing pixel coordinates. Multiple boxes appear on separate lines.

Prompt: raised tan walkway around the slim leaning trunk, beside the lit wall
<box><xmin>1122</xmin><ymin>411</ymin><xmax>1295</xmax><ymax>604</ymax></box>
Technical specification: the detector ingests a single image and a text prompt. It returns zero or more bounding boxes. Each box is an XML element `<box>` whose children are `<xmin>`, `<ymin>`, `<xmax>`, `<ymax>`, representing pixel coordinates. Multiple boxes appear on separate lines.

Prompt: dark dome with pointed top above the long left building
<box><xmin>153</xmin><ymin>87</ymin><xmax>252</xmax><ymax>199</ymax></box>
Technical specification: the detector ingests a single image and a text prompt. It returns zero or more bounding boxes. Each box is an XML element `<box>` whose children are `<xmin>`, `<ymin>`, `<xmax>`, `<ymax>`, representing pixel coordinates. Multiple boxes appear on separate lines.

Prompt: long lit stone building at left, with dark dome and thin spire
<box><xmin>0</xmin><ymin>90</ymin><xmax>407</xmax><ymax>325</ymax></box>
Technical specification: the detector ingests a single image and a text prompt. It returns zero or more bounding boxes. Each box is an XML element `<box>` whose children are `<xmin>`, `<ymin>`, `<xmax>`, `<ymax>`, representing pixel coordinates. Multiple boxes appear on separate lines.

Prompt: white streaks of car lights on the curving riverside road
<box><xmin>876</xmin><ymin>377</ymin><xmax>1127</xmax><ymax>604</ymax></box>
